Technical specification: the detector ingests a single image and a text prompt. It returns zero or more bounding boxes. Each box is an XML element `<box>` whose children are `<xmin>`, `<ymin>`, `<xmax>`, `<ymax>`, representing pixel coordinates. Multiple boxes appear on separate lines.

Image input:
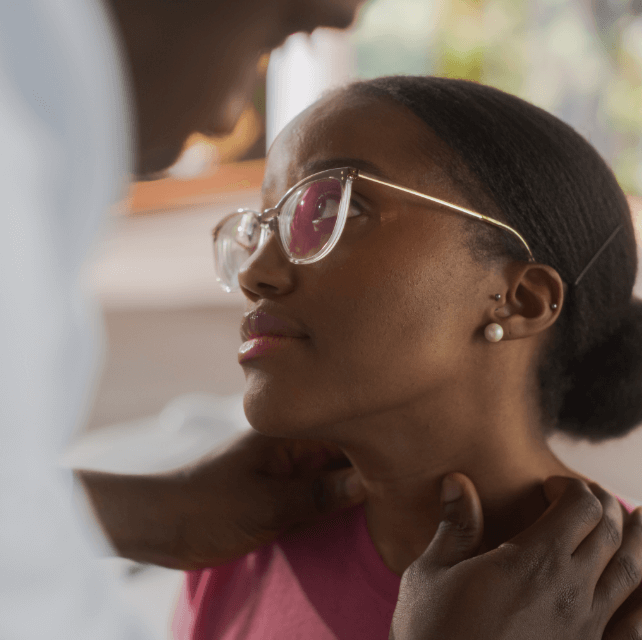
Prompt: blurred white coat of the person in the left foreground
<box><xmin>0</xmin><ymin>0</ymin><xmax>150</xmax><ymax>640</ymax></box>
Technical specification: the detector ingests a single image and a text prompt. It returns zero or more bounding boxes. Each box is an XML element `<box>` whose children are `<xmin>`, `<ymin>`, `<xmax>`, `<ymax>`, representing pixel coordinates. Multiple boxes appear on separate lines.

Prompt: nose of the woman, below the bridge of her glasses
<box><xmin>239</xmin><ymin>232</ymin><xmax>294</xmax><ymax>300</ymax></box>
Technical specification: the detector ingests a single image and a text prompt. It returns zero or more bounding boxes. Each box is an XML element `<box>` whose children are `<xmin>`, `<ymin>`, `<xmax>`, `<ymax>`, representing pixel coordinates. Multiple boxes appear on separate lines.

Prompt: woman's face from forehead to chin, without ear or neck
<box><xmin>239</xmin><ymin>92</ymin><xmax>494</xmax><ymax>439</ymax></box>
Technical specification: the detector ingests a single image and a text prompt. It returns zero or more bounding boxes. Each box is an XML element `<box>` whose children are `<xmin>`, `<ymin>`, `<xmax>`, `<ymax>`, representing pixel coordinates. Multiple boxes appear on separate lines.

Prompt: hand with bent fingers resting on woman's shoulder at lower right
<box><xmin>390</xmin><ymin>474</ymin><xmax>642</xmax><ymax>640</ymax></box>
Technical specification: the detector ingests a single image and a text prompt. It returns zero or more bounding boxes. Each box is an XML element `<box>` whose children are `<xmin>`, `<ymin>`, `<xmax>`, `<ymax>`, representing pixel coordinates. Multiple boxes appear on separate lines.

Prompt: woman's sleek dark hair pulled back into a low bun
<box><xmin>350</xmin><ymin>76</ymin><xmax>642</xmax><ymax>441</ymax></box>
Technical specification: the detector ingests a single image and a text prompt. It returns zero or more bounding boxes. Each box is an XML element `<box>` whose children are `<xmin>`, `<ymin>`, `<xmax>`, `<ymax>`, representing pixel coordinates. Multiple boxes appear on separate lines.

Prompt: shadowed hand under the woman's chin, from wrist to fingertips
<box><xmin>168</xmin><ymin>431</ymin><xmax>365</xmax><ymax>568</ymax></box>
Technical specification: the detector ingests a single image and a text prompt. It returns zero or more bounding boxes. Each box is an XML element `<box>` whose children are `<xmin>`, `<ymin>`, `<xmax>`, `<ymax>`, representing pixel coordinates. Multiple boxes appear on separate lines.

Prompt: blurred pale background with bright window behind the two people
<box><xmin>68</xmin><ymin>0</ymin><xmax>642</xmax><ymax>640</ymax></box>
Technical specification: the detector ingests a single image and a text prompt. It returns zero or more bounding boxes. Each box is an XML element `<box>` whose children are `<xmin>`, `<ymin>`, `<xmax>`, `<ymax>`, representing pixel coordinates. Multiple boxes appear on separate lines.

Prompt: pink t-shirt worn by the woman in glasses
<box><xmin>173</xmin><ymin>500</ymin><xmax>633</xmax><ymax>640</ymax></box>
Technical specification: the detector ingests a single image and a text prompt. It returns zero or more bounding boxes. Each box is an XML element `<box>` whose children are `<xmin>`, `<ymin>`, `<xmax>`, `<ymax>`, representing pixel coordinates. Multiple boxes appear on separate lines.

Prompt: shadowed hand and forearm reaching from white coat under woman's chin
<box><xmin>75</xmin><ymin>431</ymin><xmax>365</xmax><ymax>570</ymax></box>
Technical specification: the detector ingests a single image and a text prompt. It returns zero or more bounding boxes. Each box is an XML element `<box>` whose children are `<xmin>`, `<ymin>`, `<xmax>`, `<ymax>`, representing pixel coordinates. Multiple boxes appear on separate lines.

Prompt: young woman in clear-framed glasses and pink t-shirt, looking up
<box><xmin>176</xmin><ymin>77</ymin><xmax>642</xmax><ymax>640</ymax></box>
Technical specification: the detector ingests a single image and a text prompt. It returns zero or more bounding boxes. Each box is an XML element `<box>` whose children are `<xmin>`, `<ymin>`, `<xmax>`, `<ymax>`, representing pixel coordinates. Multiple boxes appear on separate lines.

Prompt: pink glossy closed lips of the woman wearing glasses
<box><xmin>239</xmin><ymin>309</ymin><xmax>309</xmax><ymax>363</ymax></box>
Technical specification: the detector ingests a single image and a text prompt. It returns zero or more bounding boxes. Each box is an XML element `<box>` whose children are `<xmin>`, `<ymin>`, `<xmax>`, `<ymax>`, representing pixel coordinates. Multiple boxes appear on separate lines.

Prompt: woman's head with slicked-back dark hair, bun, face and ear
<box><xmin>231</xmin><ymin>77</ymin><xmax>642</xmax><ymax>455</ymax></box>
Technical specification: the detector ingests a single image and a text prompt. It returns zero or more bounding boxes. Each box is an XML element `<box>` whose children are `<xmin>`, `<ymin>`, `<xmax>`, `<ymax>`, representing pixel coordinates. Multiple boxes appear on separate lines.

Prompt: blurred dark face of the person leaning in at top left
<box><xmin>107</xmin><ymin>0</ymin><xmax>363</xmax><ymax>176</ymax></box>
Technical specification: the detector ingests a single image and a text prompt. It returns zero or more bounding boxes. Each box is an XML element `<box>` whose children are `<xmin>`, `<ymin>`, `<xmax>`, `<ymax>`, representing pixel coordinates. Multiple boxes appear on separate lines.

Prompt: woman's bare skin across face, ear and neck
<box><xmin>239</xmin><ymin>92</ymin><xmax>576</xmax><ymax>575</ymax></box>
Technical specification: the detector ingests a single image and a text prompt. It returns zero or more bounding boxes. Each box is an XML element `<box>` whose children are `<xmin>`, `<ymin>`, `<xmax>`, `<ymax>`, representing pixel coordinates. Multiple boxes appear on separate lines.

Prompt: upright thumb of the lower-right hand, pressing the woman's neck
<box><xmin>424</xmin><ymin>473</ymin><xmax>484</xmax><ymax>567</ymax></box>
